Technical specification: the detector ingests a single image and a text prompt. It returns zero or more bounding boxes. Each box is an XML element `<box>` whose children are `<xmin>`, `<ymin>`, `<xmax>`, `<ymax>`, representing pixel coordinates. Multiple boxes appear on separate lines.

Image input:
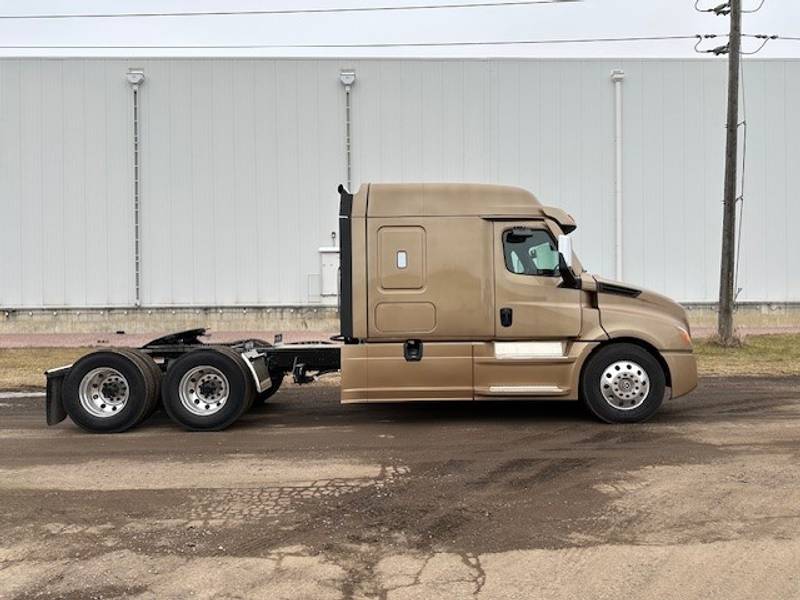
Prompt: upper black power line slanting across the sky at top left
<box><xmin>0</xmin><ymin>0</ymin><xmax>583</xmax><ymax>20</ymax></box>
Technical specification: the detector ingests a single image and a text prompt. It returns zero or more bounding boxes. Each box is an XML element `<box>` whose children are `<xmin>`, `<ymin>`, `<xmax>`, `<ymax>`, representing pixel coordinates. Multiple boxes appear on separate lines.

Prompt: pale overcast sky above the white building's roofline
<box><xmin>0</xmin><ymin>0</ymin><xmax>800</xmax><ymax>58</ymax></box>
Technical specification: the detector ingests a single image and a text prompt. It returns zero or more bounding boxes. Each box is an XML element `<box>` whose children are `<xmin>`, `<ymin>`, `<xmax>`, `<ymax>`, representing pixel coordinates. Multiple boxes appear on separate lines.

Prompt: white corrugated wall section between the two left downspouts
<box><xmin>131</xmin><ymin>59</ymin><xmax>344</xmax><ymax>306</ymax></box>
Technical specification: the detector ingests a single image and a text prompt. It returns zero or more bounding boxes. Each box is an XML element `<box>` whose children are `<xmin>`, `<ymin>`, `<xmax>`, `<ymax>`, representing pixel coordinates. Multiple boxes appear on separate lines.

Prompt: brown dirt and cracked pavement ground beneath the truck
<box><xmin>0</xmin><ymin>377</ymin><xmax>800</xmax><ymax>600</ymax></box>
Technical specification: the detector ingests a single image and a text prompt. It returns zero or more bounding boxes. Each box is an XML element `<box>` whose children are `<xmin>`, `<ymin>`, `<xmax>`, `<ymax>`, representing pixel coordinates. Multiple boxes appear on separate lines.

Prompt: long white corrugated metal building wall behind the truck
<box><xmin>0</xmin><ymin>58</ymin><xmax>800</xmax><ymax>309</ymax></box>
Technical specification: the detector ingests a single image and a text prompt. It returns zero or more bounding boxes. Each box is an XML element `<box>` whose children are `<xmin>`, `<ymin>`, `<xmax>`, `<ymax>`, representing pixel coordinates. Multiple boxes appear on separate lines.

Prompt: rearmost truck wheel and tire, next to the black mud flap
<box><xmin>62</xmin><ymin>350</ymin><xmax>156</xmax><ymax>433</ymax></box>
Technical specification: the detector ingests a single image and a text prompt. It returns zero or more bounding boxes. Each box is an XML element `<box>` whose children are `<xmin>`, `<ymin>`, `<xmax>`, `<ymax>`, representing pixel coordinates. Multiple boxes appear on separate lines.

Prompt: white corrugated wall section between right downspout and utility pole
<box><xmin>609</xmin><ymin>61</ymin><xmax>725</xmax><ymax>302</ymax></box>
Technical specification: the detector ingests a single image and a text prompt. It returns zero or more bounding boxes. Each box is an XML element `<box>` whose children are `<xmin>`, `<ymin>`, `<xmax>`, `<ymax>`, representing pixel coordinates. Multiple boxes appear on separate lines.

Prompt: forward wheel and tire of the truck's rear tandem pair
<box><xmin>161</xmin><ymin>346</ymin><xmax>255</xmax><ymax>431</ymax></box>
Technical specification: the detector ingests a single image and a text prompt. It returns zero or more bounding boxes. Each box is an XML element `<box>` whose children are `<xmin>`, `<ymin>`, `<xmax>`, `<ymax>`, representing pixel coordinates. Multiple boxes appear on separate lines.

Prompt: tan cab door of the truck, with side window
<box><xmin>494</xmin><ymin>221</ymin><xmax>581</xmax><ymax>340</ymax></box>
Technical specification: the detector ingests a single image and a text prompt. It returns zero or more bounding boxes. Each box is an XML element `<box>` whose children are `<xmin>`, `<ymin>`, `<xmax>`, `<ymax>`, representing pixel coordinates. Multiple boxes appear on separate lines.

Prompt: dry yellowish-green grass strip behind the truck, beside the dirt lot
<box><xmin>0</xmin><ymin>334</ymin><xmax>800</xmax><ymax>390</ymax></box>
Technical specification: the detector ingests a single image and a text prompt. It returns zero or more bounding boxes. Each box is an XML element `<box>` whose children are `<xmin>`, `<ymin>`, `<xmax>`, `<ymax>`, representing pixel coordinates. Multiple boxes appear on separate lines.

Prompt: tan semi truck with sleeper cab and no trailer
<box><xmin>47</xmin><ymin>184</ymin><xmax>697</xmax><ymax>432</ymax></box>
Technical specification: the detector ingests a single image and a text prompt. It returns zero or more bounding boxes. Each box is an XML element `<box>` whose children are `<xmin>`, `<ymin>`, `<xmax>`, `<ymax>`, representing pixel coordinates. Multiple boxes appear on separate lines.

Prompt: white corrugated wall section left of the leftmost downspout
<box><xmin>0</xmin><ymin>60</ymin><xmax>133</xmax><ymax>307</ymax></box>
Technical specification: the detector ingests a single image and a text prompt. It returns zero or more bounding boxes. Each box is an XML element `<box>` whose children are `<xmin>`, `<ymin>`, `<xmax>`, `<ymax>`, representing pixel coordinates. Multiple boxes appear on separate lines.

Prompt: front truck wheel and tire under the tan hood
<box><xmin>580</xmin><ymin>343</ymin><xmax>666</xmax><ymax>423</ymax></box>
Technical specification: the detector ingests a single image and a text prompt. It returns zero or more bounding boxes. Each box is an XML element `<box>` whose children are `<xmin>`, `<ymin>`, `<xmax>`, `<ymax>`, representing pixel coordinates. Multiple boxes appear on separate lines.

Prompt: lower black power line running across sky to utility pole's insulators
<box><xmin>0</xmin><ymin>35</ymin><xmax>697</xmax><ymax>50</ymax></box>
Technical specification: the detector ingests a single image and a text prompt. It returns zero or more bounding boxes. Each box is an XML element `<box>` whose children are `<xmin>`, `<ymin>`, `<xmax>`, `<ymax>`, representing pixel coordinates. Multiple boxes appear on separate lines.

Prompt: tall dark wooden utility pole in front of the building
<box><xmin>717</xmin><ymin>0</ymin><xmax>742</xmax><ymax>346</ymax></box>
